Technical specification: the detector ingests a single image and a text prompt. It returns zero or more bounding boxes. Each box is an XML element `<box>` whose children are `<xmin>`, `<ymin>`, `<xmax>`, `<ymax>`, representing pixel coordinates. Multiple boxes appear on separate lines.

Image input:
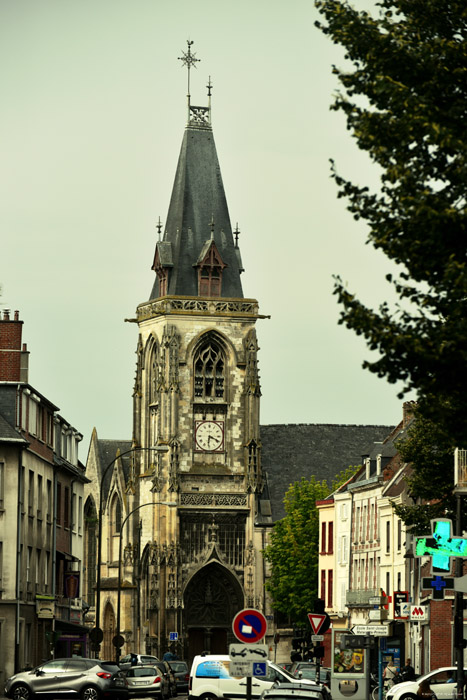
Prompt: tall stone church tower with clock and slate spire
<box><xmin>128</xmin><ymin>42</ymin><xmax>266</xmax><ymax>658</ymax></box>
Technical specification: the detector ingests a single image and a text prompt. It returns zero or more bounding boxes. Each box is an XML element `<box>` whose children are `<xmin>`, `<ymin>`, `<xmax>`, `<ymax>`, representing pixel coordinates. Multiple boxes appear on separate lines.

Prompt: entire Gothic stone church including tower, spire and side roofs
<box><xmin>83</xmin><ymin>49</ymin><xmax>390</xmax><ymax>660</ymax></box>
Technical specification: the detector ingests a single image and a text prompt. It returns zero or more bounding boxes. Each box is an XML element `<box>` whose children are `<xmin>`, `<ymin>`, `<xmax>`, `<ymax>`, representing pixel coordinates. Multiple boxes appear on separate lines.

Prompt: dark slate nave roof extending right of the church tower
<box><xmin>261</xmin><ymin>423</ymin><xmax>394</xmax><ymax>522</ymax></box>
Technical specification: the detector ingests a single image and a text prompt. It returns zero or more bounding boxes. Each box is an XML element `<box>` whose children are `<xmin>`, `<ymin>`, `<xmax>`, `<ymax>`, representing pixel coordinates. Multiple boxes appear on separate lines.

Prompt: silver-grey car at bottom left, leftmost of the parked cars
<box><xmin>5</xmin><ymin>657</ymin><xmax>128</xmax><ymax>700</ymax></box>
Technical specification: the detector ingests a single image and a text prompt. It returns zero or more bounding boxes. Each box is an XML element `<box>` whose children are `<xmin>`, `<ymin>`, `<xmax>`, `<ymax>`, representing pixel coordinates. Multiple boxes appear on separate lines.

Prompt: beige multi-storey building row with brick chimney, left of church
<box><xmin>0</xmin><ymin>311</ymin><xmax>87</xmax><ymax>685</ymax></box>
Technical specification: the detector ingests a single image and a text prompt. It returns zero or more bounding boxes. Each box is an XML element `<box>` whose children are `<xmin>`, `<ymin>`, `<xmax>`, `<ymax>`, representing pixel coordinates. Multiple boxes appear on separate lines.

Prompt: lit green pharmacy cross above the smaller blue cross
<box><xmin>415</xmin><ymin>518</ymin><xmax>467</xmax><ymax>572</ymax></box>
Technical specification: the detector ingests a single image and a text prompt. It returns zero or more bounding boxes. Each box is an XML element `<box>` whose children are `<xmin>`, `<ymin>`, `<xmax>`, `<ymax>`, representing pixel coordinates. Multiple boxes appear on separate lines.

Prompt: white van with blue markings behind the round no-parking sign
<box><xmin>188</xmin><ymin>654</ymin><xmax>315</xmax><ymax>700</ymax></box>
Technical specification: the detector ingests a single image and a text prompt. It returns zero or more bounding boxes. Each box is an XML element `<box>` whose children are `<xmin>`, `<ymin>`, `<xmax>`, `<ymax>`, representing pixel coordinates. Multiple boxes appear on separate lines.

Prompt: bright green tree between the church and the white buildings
<box><xmin>263</xmin><ymin>467</ymin><xmax>358</xmax><ymax>622</ymax></box>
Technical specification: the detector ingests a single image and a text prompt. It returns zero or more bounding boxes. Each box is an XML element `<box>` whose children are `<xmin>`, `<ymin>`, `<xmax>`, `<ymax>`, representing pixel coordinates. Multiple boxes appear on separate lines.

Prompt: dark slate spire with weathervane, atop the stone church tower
<box><xmin>150</xmin><ymin>42</ymin><xmax>243</xmax><ymax>299</ymax></box>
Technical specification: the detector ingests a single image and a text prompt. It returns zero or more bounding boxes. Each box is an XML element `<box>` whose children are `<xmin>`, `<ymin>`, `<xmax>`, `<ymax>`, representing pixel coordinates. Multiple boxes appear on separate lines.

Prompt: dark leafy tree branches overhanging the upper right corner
<box><xmin>315</xmin><ymin>0</ymin><xmax>467</xmax><ymax>446</ymax></box>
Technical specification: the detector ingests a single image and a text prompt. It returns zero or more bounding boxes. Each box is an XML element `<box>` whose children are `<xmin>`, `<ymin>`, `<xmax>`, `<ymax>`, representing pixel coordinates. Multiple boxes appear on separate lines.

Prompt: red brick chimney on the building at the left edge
<box><xmin>0</xmin><ymin>309</ymin><xmax>29</xmax><ymax>382</ymax></box>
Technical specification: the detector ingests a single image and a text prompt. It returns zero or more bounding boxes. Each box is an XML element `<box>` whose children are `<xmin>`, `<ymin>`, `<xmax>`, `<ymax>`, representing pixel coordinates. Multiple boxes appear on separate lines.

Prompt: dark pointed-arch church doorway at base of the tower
<box><xmin>184</xmin><ymin>562</ymin><xmax>244</xmax><ymax>660</ymax></box>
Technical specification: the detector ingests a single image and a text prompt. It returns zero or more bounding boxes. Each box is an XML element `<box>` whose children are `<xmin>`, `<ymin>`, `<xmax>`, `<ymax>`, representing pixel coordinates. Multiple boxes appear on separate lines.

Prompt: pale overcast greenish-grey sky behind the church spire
<box><xmin>0</xmin><ymin>0</ymin><xmax>401</xmax><ymax>454</ymax></box>
